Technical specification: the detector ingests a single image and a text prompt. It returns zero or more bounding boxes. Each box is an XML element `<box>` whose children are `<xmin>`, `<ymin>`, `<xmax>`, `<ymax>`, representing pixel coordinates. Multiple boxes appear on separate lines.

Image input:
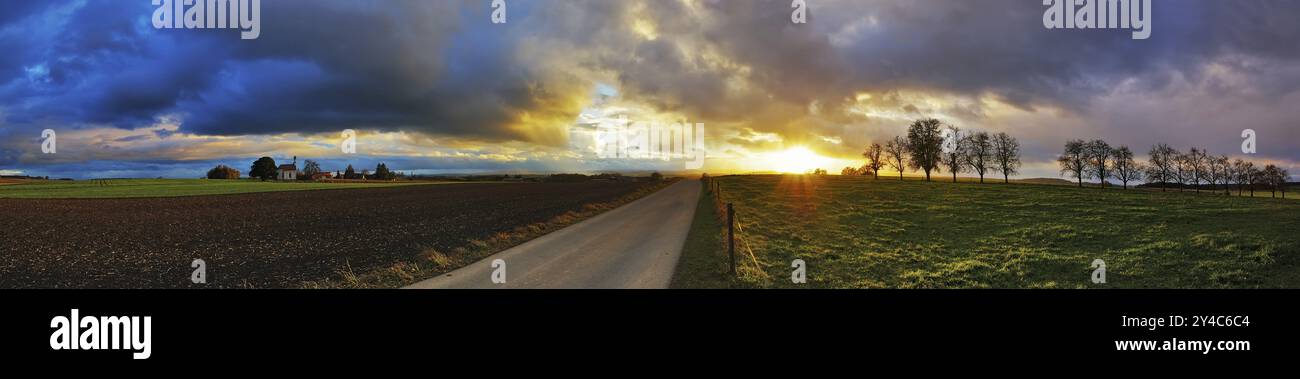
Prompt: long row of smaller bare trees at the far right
<box><xmin>1057</xmin><ymin>139</ymin><xmax>1291</xmax><ymax>199</ymax></box>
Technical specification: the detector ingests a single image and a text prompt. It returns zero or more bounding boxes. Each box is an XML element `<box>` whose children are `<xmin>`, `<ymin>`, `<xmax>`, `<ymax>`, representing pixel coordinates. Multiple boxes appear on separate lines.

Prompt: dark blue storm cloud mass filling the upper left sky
<box><xmin>0</xmin><ymin>1</ymin><xmax>576</xmax><ymax>143</ymax></box>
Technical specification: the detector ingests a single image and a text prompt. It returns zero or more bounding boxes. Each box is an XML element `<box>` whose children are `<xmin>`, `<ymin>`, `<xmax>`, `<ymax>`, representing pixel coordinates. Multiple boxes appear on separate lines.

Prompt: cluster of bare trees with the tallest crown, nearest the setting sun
<box><xmin>841</xmin><ymin>118</ymin><xmax>1021</xmax><ymax>183</ymax></box>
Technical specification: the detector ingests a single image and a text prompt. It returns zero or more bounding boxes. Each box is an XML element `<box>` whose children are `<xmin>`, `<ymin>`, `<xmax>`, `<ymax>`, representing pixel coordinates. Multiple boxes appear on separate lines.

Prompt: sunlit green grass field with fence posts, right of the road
<box><xmin>673</xmin><ymin>175</ymin><xmax>1300</xmax><ymax>288</ymax></box>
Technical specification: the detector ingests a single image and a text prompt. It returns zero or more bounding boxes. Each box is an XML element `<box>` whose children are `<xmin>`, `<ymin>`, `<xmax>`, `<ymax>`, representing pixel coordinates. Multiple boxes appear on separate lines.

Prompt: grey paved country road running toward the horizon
<box><xmin>406</xmin><ymin>180</ymin><xmax>701</xmax><ymax>288</ymax></box>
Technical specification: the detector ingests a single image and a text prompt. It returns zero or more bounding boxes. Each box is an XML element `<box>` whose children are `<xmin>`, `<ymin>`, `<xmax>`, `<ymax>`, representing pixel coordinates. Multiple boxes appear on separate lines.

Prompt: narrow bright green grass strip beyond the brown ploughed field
<box><xmin>0</xmin><ymin>179</ymin><xmax>428</xmax><ymax>199</ymax></box>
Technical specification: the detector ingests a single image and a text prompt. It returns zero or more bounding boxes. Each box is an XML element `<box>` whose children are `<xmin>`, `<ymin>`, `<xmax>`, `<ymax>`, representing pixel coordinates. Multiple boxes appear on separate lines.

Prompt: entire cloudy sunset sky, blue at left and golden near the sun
<box><xmin>0</xmin><ymin>0</ymin><xmax>1300</xmax><ymax>178</ymax></box>
